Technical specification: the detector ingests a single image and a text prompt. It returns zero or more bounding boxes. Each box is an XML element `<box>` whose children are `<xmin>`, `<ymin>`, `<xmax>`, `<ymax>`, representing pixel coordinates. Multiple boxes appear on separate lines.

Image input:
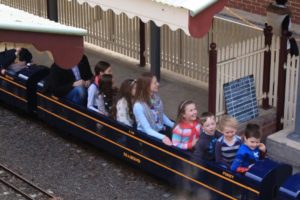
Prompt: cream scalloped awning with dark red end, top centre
<box><xmin>74</xmin><ymin>0</ymin><xmax>228</xmax><ymax>37</ymax></box>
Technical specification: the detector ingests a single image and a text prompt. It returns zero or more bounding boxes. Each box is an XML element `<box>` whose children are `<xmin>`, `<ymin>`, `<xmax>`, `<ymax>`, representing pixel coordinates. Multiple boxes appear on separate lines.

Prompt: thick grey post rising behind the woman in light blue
<box><xmin>150</xmin><ymin>21</ymin><xmax>160</xmax><ymax>80</ymax></box>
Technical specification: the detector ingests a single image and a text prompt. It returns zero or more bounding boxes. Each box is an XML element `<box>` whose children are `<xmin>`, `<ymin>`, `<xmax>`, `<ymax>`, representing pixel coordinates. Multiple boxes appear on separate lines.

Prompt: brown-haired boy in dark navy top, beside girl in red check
<box><xmin>193</xmin><ymin>112</ymin><xmax>222</xmax><ymax>161</ymax></box>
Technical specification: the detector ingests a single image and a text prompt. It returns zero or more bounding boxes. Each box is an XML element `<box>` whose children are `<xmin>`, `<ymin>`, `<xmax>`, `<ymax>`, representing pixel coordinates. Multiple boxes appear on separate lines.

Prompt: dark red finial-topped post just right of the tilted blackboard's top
<box><xmin>262</xmin><ymin>24</ymin><xmax>273</xmax><ymax>110</ymax></box>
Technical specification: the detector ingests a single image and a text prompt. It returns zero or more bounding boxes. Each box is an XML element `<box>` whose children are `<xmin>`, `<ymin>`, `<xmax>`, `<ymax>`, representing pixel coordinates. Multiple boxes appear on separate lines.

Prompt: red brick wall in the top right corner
<box><xmin>227</xmin><ymin>0</ymin><xmax>300</xmax><ymax>24</ymax></box>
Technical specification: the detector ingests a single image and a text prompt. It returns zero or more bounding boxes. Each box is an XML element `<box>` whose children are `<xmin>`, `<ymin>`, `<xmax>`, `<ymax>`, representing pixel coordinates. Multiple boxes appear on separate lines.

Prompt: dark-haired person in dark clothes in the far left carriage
<box><xmin>0</xmin><ymin>48</ymin><xmax>32</xmax><ymax>74</ymax></box>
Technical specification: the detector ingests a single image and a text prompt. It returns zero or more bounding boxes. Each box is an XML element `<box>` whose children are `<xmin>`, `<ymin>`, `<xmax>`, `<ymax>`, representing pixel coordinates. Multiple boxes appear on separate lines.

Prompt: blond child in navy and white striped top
<box><xmin>215</xmin><ymin>115</ymin><xmax>242</xmax><ymax>169</ymax></box>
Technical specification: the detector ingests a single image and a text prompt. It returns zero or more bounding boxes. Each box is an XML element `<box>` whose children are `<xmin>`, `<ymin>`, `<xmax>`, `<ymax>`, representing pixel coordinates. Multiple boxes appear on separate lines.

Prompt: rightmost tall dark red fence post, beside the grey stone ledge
<box><xmin>276</xmin><ymin>31</ymin><xmax>288</xmax><ymax>131</ymax></box>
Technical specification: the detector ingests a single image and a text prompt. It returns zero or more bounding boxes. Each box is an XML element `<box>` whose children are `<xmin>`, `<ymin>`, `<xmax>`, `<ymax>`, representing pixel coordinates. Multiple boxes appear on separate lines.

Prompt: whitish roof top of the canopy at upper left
<box><xmin>0</xmin><ymin>4</ymin><xmax>87</xmax><ymax>36</ymax></box>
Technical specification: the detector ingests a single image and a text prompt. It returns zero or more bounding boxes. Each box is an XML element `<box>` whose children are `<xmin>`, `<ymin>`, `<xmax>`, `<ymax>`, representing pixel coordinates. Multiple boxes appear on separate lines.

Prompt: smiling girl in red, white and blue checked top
<box><xmin>172</xmin><ymin>100</ymin><xmax>201</xmax><ymax>150</ymax></box>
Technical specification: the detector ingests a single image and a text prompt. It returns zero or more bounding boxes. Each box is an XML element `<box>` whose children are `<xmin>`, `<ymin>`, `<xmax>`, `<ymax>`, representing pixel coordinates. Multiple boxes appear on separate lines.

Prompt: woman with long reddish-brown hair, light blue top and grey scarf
<box><xmin>133</xmin><ymin>73</ymin><xmax>174</xmax><ymax>146</ymax></box>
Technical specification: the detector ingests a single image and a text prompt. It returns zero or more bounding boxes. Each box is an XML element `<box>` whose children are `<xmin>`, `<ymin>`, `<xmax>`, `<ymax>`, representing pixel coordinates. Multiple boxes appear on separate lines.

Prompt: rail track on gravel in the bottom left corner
<box><xmin>0</xmin><ymin>164</ymin><xmax>59</xmax><ymax>200</ymax></box>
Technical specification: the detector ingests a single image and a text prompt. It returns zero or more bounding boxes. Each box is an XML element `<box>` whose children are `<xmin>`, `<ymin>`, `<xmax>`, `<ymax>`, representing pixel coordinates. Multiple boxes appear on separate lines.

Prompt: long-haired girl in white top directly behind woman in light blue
<box><xmin>111</xmin><ymin>79</ymin><xmax>136</xmax><ymax>126</ymax></box>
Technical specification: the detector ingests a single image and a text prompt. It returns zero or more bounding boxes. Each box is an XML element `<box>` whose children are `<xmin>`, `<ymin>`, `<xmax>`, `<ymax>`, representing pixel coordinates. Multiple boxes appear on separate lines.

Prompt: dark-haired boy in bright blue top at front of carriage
<box><xmin>231</xmin><ymin>124</ymin><xmax>266</xmax><ymax>173</ymax></box>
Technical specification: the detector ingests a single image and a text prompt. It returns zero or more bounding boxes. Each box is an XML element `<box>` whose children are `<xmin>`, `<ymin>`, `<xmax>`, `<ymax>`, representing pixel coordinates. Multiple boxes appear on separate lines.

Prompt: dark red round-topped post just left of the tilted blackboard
<box><xmin>208</xmin><ymin>42</ymin><xmax>217</xmax><ymax>114</ymax></box>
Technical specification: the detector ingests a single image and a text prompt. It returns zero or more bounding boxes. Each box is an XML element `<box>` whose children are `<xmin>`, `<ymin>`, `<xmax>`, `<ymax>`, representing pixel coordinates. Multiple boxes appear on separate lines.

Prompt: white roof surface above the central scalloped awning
<box><xmin>152</xmin><ymin>0</ymin><xmax>218</xmax><ymax>16</ymax></box>
